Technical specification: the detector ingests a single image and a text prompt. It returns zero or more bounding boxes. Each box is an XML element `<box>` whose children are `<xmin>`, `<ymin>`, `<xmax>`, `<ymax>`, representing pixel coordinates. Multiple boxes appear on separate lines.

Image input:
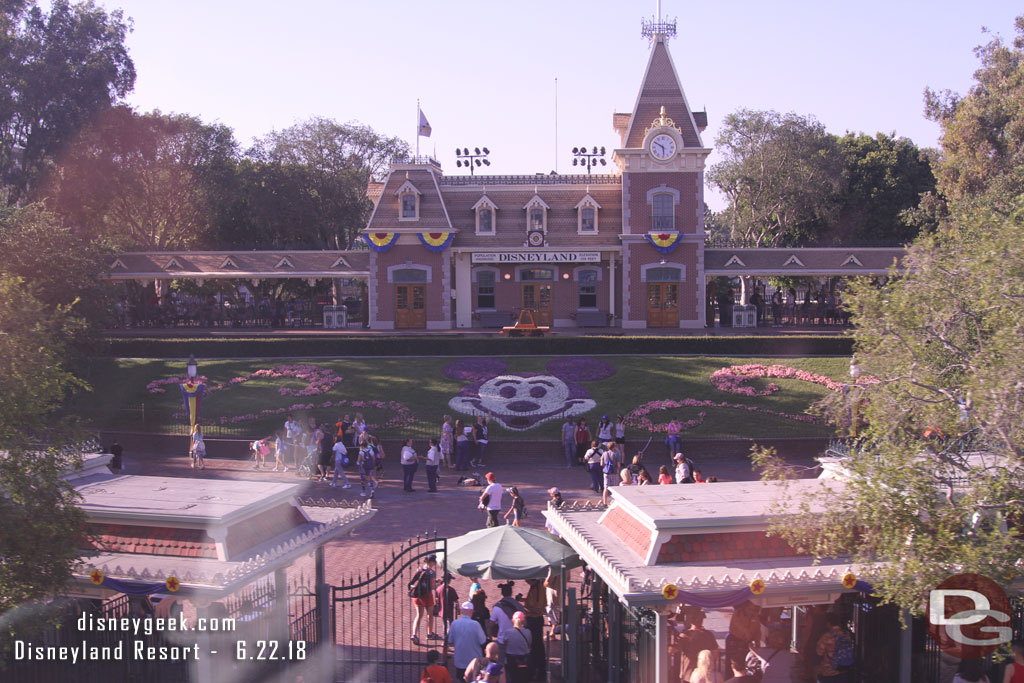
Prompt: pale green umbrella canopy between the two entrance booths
<box><xmin>447</xmin><ymin>526</ymin><xmax>582</xmax><ymax>579</ymax></box>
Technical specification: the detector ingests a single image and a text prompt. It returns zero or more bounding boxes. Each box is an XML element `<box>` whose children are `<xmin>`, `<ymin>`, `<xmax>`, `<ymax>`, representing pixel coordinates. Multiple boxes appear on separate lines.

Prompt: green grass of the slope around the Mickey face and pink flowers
<box><xmin>74</xmin><ymin>356</ymin><xmax>849</xmax><ymax>439</ymax></box>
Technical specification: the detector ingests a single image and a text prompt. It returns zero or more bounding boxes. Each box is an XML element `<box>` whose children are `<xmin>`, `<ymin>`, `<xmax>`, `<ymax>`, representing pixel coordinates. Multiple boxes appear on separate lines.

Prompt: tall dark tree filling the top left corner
<box><xmin>0</xmin><ymin>0</ymin><xmax>135</xmax><ymax>204</ymax></box>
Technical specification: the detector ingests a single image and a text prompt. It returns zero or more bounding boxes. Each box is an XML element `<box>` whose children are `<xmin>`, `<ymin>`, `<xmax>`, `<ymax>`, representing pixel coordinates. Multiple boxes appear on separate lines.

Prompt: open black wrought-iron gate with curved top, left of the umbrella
<box><xmin>331</xmin><ymin>532</ymin><xmax>447</xmax><ymax>683</ymax></box>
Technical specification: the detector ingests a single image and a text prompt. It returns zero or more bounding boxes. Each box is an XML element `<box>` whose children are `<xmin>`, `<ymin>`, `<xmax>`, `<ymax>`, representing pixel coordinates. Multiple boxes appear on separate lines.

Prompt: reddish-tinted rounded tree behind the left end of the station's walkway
<box><xmin>47</xmin><ymin>106</ymin><xmax>238</xmax><ymax>250</ymax></box>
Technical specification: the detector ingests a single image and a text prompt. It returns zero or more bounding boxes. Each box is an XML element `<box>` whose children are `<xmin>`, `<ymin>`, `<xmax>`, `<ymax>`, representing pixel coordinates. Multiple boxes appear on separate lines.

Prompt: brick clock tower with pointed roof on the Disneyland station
<box><xmin>612</xmin><ymin>19</ymin><xmax>711</xmax><ymax>329</ymax></box>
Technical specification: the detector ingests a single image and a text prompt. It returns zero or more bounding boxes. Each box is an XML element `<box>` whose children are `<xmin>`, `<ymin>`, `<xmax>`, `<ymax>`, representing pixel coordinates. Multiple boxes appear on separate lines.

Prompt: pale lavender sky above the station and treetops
<box><xmin>97</xmin><ymin>0</ymin><xmax>1022</xmax><ymax>210</ymax></box>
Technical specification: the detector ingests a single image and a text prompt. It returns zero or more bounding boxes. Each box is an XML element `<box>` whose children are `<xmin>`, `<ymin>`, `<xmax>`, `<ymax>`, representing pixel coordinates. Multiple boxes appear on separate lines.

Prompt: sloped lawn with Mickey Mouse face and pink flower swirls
<box><xmin>76</xmin><ymin>356</ymin><xmax>849</xmax><ymax>439</ymax></box>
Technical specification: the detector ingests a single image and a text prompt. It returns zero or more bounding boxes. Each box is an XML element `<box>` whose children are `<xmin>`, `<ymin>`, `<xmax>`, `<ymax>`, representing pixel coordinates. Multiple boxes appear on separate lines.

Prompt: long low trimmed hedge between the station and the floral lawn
<box><xmin>106</xmin><ymin>335</ymin><xmax>853</xmax><ymax>358</ymax></box>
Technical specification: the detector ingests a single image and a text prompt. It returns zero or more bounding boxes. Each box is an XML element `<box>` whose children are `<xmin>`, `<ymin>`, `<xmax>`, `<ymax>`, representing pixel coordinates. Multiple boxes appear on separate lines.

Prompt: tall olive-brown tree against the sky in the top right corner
<box><xmin>925</xmin><ymin>15</ymin><xmax>1024</xmax><ymax>213</ymax></box>
